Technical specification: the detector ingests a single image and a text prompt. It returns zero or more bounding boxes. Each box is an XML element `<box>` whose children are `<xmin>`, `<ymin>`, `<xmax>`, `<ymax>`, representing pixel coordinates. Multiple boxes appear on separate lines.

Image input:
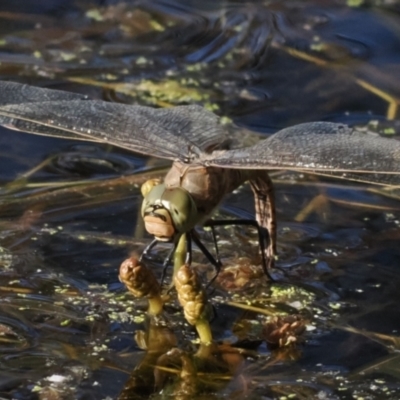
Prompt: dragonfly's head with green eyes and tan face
<box><xmin>142</xmin><ymin>184</ymin><xmax>198</xmax><ymax>242</ymax></box>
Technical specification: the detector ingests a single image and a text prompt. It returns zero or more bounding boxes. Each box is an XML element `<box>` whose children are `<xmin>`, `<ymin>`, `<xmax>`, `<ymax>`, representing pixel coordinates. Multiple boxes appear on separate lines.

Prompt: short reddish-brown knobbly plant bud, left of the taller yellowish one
<box><xmin>119</xmin><ymin>256</ymin><xmax>161</xmax><ymax>298</ymax></box>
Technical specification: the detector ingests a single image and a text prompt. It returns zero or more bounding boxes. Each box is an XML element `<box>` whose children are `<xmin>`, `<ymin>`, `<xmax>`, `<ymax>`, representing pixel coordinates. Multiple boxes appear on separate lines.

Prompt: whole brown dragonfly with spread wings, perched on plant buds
<box><xmin>0</xmin><ymin>82</ymin><xmax>400</xmax><ymax>282</ymax></box>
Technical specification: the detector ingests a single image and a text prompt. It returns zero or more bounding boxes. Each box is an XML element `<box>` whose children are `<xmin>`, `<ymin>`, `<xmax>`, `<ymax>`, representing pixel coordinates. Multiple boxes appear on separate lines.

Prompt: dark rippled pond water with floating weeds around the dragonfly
<box><xmin>0</xmin><ymin>0</ymin><xmax>400</xmax><ymax>399</ymax></box>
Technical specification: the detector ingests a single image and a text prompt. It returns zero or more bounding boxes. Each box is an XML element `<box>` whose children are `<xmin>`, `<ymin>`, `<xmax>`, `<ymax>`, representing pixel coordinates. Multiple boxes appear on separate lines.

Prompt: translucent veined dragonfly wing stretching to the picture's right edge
<box><xmin>205</xmin><ymin>122</ymin><xmax>400</xmax><ymax>185</ymax></box>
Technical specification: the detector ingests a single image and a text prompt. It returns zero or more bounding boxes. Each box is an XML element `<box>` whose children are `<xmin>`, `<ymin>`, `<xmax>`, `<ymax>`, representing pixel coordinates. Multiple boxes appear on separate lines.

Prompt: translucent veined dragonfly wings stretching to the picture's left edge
<box><xmin>0</xmin><ymin>82</ymin><xmax>225</xmax><ymax>160</ymax></box>
